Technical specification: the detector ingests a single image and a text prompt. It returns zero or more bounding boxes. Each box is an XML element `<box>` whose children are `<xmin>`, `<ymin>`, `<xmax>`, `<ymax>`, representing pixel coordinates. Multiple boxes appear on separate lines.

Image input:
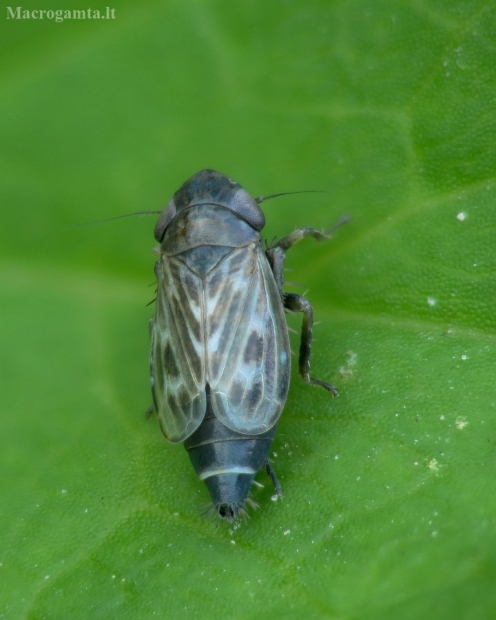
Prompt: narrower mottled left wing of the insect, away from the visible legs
<box><xmin>150</xmin><ymin>256</ymin><xmax>206</xmax><ymax>443</ymax></box>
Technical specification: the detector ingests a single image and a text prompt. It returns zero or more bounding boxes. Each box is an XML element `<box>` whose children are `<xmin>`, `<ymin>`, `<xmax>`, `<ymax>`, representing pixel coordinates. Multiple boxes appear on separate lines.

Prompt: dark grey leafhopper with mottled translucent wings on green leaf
<box><xmin>150</xmin><ymin>170</ymin><xmax>344</xmax><ymax>521</ymax></box>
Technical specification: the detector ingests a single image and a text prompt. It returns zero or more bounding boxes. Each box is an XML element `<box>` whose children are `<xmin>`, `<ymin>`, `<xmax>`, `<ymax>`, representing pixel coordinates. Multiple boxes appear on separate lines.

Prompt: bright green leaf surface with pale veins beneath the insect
<box><xmin>0</xmin><ymin>0</ymin><xmax>496</xmax><ymax>620</ymax></box>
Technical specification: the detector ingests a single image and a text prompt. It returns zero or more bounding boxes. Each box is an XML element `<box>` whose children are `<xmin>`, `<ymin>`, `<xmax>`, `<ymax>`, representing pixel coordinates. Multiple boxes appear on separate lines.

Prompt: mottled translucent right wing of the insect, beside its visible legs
<box><xmin>205</xmin><ymin>244</ymin><xmax>290</xmax><ymax>435</ymax></box>
